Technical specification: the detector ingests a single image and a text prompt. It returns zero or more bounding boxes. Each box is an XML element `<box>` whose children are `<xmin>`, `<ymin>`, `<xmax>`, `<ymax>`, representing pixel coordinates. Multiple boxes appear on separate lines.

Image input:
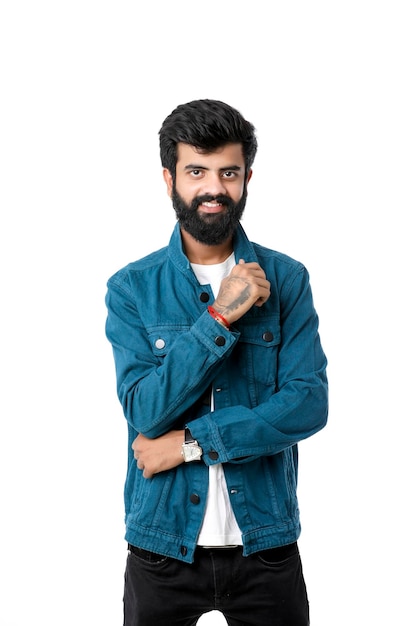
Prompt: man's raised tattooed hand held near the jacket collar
<box><xmin>213</xmin><ymin>259</ymin><xmax>271</xmax><ymax>324</ymax></box>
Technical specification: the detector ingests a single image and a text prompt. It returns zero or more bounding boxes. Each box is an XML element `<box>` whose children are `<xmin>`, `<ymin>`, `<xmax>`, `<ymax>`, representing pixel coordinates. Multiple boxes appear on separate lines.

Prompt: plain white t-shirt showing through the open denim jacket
<box><xmin>191</xmin><ymin>253</ymin><xmax>242</xmax><ymax>546</ymax></box>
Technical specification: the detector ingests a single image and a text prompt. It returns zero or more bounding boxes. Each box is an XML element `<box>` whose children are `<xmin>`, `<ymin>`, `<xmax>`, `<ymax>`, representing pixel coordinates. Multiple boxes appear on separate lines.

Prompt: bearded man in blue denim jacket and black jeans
<box><xmin>106</xmin><ymin>100</ymin><xmax>327</xmax><ymax>626</ymax></box>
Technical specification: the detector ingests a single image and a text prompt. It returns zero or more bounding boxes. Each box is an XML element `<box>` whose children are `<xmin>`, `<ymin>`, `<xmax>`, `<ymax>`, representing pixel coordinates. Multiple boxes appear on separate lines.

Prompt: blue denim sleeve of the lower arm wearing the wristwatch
<box><xmin>188</xmin><ymin>265</ymin><xmax>328</xmax><ymax>464</ymax></box>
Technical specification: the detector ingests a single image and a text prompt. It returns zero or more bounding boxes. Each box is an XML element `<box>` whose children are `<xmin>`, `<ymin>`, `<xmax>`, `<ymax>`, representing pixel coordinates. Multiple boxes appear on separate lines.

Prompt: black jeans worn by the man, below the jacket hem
<box><xmin>124</xmin><ymin>543</ymin><xmax>310</xmax><ymax>626</ymax></box>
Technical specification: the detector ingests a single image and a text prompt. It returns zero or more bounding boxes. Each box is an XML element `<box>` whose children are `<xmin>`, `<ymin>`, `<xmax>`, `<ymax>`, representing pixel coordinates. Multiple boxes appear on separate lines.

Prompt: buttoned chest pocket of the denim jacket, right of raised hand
<box><xmin>235</xmin><ymin>316</ymin><xmax>281</xmax><ymax>387</ymax></box>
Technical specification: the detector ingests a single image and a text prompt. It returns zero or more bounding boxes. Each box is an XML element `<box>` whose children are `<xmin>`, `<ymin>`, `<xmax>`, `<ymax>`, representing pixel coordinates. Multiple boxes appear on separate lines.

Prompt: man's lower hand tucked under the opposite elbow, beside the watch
<box><xmin>132</xmin><ymin>430</ymin><xmax>184</xmax><ymax>478</ymax></box>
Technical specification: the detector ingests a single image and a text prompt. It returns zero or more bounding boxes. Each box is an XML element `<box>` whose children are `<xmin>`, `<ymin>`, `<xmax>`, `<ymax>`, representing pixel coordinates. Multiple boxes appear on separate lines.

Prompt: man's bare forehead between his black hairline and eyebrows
<box><xmin>177</xmin><ymin>143</ymin><xmax>245</xmax><ymax>169</ymax></box>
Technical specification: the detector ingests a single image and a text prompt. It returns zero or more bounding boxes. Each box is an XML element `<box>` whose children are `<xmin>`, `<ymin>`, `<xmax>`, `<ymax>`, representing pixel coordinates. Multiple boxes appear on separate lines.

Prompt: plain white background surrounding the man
<box><xmin>0</xmin><ymin>0</ymin><xmax>417</xmax><ymax>626</ymax></box>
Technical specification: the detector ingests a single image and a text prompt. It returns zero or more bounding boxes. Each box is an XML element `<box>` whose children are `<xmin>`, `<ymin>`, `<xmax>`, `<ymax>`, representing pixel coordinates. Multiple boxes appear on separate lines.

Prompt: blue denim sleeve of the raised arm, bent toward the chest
<box><xmin>105</xmin><ymin>274</ymin><xmax>239</xmax><ymax>438</ymax></box>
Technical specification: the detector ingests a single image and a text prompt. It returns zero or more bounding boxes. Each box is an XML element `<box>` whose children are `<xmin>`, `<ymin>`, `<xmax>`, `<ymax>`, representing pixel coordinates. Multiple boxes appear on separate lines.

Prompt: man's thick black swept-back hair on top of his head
<box><xmin>159</xmin><ymin>100</ymin><xmax>258</xmax><ymax>180</ymax></box>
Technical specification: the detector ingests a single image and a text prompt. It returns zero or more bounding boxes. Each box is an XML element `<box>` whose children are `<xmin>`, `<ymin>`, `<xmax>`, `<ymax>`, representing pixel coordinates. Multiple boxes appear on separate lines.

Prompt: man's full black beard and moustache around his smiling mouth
<box><xmin>172</xmin><ymin>185</ymin><xmax>247</xmax><ymax>246</ymax></box>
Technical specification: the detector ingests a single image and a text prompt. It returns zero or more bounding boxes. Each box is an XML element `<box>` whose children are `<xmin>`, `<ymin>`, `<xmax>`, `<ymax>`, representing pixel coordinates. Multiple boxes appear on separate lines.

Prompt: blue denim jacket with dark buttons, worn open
<box><xmin>106</xmin><ymin>224</ymin><xmax>328</xmax><ymax>562</ymax></box>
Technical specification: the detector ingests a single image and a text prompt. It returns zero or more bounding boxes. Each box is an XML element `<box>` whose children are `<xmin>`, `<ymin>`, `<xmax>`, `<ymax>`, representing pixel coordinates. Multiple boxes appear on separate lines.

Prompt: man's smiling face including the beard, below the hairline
<box><xmin>164</xmin><ymin>143</ymin><xmax>251</xmax><ymax>245</ymax></box>
